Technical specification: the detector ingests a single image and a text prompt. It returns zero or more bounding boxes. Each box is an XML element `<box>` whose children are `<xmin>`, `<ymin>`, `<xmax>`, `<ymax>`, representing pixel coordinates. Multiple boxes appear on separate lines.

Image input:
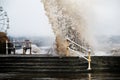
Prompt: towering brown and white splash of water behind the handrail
<box><xmin>42</xmin><ymin>0</ymin><xmax>92</xmax><ymax>55</ymax></box>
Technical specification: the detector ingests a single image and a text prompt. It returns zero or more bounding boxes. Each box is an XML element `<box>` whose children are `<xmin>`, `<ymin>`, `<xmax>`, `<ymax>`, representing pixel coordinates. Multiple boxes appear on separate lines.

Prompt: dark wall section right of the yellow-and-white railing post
<box><xmin>91</xmin><ymin>56</ymin><xmax>120</xmax><ymax>73</ymax></box>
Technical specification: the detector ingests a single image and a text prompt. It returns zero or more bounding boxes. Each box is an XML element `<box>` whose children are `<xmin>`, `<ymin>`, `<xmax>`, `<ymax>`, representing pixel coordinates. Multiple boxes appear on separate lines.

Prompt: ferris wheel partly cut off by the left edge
<box><xmin>0</xmin><ymin>6</ymin><xmax>9</xmax><ymax>34</ymax></box>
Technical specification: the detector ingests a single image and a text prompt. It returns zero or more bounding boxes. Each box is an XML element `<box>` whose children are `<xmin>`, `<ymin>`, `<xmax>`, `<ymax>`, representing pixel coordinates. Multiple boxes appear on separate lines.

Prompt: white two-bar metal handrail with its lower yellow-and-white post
<box><xmin>66</xmin><ymin>38</ymin><xmax>91</xmax><ymax>70</ymax></box>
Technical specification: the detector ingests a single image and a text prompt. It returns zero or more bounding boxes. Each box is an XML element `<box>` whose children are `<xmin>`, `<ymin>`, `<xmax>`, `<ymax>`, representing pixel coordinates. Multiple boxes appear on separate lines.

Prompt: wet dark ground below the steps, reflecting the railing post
<box><xmin>0</xmin><ymin>72</ymin><xmax>120</xmax><ymax>80</ymax></box>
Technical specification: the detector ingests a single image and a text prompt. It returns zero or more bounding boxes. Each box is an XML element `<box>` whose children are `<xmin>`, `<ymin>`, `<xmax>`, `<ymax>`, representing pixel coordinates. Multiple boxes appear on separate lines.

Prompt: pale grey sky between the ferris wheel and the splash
<box><xmin>0</xmin><ymin>0</ymin><xmax>53</xmax><ymax>36</ymax></box>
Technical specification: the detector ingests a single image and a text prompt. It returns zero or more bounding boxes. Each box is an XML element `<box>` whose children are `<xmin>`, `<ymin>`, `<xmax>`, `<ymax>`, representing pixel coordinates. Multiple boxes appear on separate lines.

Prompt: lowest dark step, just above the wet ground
<box><xmin>0</xmin><ymin>69</ymin><xmax>89</xmax><ymax>73</ymax></box>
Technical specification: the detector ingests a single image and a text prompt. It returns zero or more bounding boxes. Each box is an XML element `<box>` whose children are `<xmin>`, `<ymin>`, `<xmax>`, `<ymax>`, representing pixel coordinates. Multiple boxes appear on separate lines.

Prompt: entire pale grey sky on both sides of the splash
<box><xmin>0</xmin><ymin>0</ymin><xmax>120</xmax><ymax>36</ymax></box>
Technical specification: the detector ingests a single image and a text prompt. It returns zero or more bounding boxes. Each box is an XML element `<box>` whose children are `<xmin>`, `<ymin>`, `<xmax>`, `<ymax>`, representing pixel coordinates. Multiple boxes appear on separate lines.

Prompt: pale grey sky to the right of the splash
<box><xmin>91</xmin><ymin>0</ymin><xmax>120</xmax><ymax>35</ymax></box>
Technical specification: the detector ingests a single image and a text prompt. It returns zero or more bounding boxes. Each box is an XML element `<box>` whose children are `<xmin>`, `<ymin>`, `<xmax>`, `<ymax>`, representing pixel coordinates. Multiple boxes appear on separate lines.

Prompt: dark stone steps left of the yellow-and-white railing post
<box><xmin>0</xmin><ymin>56</ymin><xmax>89</xmax><ymax>74</ymax></box>
